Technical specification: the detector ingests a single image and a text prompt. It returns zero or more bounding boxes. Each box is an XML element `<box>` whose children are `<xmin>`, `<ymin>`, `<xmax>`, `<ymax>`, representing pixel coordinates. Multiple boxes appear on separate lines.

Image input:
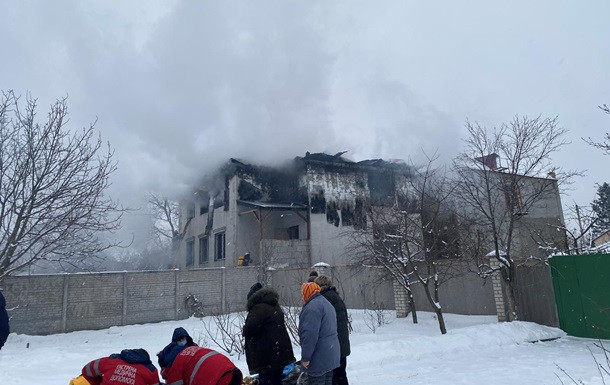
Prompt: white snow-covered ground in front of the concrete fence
<box><xmin>0</xmin><ymin>310</ymin><xmax>610</xmax><ymax>385</ymax></box>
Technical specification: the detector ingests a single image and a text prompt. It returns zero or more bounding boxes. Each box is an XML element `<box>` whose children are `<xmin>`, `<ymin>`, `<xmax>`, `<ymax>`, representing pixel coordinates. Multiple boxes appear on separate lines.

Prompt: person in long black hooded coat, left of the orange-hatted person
<box><xmin>243</xmin><ymin>283</ymin><xmax>296</xmax><ymax>385</ymax></box>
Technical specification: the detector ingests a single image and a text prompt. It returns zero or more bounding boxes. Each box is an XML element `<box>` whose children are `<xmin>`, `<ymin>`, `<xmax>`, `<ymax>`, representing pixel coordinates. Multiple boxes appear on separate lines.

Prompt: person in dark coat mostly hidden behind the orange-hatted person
<box><xmin>315</xmin><ymin>275</ymin><xmax>351</xmax><ymax>385</ymax></box>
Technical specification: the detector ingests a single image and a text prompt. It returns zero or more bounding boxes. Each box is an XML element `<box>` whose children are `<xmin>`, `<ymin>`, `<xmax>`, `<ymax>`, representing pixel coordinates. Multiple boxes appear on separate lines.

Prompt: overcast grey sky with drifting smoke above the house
<box><xmin>0</xmin><ymin>0</ymin><xmax>610</xmax><ymax>243</ymax></box>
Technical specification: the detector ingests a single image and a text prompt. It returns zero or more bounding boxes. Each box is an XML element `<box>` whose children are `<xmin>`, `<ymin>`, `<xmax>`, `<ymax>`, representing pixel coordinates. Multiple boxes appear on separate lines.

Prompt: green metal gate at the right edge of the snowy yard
<box><xmin>549</xmin><ymin>254</ymin><xmax>610</xmax><ymax>339</ymax></box>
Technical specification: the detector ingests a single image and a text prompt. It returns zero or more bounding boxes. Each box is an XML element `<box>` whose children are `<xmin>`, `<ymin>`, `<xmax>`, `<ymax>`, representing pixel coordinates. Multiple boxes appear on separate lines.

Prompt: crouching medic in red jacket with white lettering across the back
<box><xmin>82</xmin><ymin>349</ymin><xmax>159</xmax><ymax>385</ymax></box>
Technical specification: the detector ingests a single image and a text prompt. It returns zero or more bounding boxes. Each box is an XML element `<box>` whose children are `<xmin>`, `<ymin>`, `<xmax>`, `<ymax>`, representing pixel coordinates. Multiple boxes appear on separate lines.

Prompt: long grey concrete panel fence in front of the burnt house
<box><xmin>2</xmin><ymin>265</ymin><xmax>558</xmax><ymax>334</ymax></box>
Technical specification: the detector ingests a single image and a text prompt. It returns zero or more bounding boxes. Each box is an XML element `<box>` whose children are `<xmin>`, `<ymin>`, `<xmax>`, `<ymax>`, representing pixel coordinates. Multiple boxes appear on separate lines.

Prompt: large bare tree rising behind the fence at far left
<box><xmin>0</xmin><ymin>91</ymin><xmax>123</xmax><ymax>279</ymax></box>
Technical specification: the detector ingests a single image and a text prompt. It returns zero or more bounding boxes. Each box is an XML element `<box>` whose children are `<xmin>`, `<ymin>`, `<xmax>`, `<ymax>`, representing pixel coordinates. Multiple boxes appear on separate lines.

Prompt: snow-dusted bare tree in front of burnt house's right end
<box><xmin>346</xmin><ymin>156</ymin><xmax>460</xmax><ymax>334</ymax></box>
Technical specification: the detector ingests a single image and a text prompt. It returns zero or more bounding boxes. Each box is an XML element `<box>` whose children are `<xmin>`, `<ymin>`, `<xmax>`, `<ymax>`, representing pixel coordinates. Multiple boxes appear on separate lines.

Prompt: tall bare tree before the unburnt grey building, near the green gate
<box><xmin>454</xmin><ymin>116</ymin><xmax>578</xmax><ymax>320</ymax></box>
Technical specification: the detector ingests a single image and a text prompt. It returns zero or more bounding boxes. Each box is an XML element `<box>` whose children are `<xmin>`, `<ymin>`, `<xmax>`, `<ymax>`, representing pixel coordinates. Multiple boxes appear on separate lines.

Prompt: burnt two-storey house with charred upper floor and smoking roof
<box><xmin>179</xmin><ymin>153</ymin><xmax>411</xmax><ymax>268</ymax></box>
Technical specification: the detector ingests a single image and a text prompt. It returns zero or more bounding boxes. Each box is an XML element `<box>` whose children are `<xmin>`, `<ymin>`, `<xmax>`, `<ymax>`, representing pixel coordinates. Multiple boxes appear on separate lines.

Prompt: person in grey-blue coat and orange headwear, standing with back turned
<box><xmin>299</xmin><ymin>282</ymin><xmax>341</xmax><ymax>385</ymax></box>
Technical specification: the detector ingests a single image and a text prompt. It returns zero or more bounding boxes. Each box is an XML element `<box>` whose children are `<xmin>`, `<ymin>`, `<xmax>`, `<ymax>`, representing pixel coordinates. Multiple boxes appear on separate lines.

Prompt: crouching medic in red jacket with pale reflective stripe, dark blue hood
<box><xmin>157</xmin><ymin>328</ymin><xmax>243</xmax><ymax>385</ymax></box>
